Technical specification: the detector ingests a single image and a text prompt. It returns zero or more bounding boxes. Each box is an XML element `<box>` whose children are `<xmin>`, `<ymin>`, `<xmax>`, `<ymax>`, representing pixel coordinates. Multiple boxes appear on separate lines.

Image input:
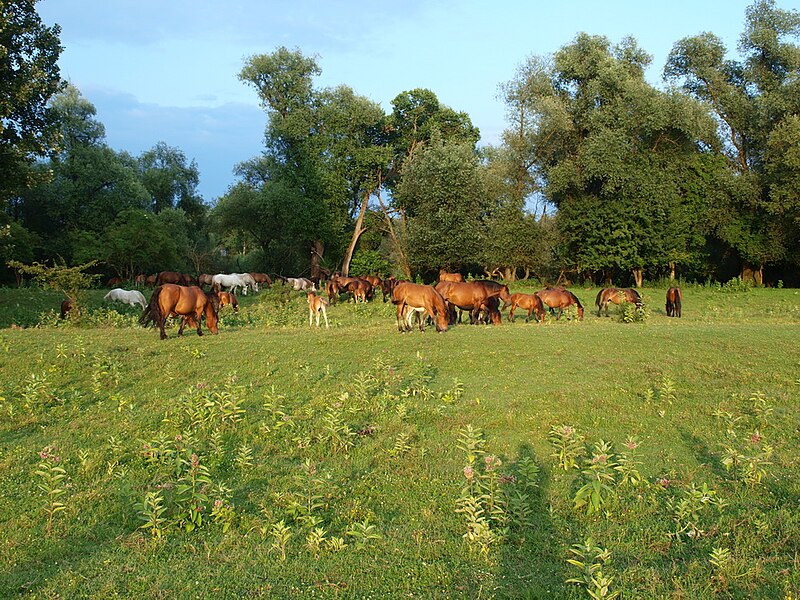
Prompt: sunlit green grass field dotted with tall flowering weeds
<box><xmin>0</xmin><ymin>285</ymin><xmax>800</xmax><ymax>599</ymax></box>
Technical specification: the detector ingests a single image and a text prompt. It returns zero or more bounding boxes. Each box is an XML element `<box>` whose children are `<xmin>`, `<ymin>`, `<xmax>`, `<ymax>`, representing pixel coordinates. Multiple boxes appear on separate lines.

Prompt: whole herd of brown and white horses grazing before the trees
<box><xmin>89</xmin><ymin>271</ymin><xmax>681</xmax><ymax>339</ymax></box>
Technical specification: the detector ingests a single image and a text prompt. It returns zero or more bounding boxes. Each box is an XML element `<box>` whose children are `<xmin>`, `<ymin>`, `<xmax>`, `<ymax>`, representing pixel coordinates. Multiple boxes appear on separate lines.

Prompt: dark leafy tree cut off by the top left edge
<box><xmin>0</xmin><ymin>0</ymin><xmax>63</xmax><ymax>200</ymax></box>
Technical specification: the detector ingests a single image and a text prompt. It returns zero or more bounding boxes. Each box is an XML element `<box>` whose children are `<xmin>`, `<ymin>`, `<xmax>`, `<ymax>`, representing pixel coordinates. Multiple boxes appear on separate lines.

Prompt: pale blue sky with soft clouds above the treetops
<box><xmin>36</xmin><ymin>0</ymin><xmax>800</xmax><ymax>203</ymax></box>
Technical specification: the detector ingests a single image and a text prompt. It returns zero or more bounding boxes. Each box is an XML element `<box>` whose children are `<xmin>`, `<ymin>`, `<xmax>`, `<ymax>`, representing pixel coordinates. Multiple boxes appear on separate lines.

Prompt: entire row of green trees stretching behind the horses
<box><xmin>0</xmin><ymin>0</ymin><xmax>800</xmax><ymax>285</ymax></box>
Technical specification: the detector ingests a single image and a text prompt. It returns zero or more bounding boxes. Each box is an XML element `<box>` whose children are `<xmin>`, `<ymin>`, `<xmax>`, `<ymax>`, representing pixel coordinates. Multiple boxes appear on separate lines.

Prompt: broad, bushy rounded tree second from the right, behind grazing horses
<box><xmin>507</xmin><ymin>34</ymin><xmax>714</xmax><ymax>285</ymax></box>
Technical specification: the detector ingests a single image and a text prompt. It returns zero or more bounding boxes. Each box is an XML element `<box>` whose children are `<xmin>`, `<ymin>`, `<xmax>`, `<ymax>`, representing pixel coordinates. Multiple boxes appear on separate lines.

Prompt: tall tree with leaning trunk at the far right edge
<box><xmin>664</xmin><ymin>0</ymin><xmax>800</xmax><ymax>283</ymax></box>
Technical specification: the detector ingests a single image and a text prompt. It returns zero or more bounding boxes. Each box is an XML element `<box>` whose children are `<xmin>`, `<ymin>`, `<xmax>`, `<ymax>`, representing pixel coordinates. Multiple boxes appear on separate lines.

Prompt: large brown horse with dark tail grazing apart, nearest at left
<box><xmin>139</xmin><ymin>283</ymin><xmax>219</xmax><ymax>340</ymax></box>
